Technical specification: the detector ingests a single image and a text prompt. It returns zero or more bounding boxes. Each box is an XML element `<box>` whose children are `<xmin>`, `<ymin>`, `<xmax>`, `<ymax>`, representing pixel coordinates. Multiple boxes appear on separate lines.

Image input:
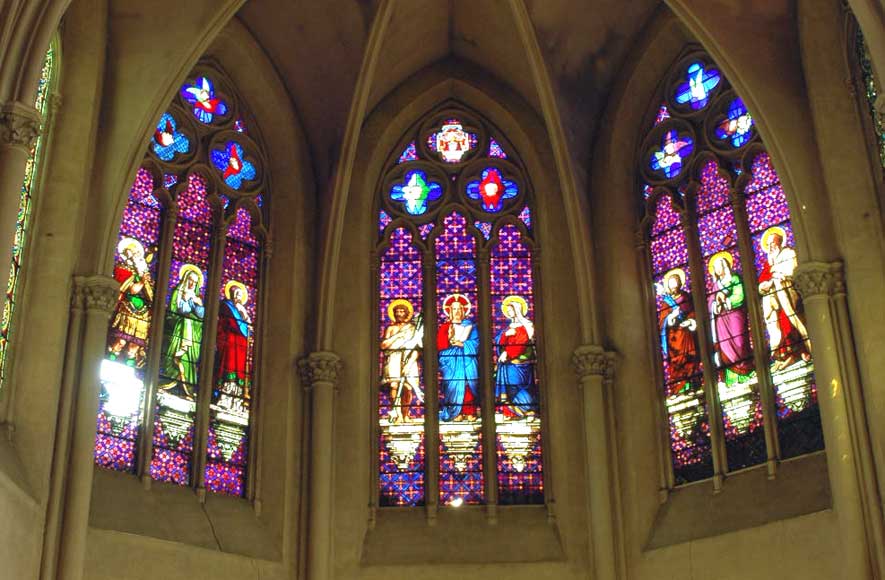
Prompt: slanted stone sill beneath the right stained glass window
<box><xmin>645</xmin><ymin>451</ymin><xmax>832</xmax><ymax>550</ymax></box>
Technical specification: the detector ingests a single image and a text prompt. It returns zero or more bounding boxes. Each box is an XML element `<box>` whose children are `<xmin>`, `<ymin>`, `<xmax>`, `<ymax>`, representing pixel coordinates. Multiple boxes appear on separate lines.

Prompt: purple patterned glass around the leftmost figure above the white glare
<box><xmin>95</xmin><ymin>168</ymin><xmax>161</xmax><ymax>472</ymax></box>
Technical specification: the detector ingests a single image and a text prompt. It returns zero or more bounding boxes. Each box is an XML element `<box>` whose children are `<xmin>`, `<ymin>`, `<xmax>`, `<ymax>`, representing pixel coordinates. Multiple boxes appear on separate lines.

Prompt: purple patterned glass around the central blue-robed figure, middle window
<box><xmin>435</xmin><ymin>213</ymin><xmax>484</xmax><ymax>505</ymax></box>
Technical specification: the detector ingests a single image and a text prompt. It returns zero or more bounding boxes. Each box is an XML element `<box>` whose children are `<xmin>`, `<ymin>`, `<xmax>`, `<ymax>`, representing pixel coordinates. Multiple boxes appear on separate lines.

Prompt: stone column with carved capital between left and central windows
<box><xmin>298</xmin><ymin>351</ymin><xmax>342</xmax><ymax>580</ymax></box>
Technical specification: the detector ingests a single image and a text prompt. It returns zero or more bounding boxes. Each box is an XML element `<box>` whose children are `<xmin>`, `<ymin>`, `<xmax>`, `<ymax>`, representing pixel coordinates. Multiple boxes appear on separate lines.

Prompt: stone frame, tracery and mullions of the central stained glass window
<box><xmin>370</xmin><ymin>103</ymin><xmax>552</xmax><ymax>518</ymax></box>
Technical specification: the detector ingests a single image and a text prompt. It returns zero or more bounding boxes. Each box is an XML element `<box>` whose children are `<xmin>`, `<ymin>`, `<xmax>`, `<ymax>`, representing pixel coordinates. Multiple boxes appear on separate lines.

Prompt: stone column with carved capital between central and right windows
<box><xmin>572</xmin><ymin>345</ymin><xmax>618</xmax><ymax>580</ymax></box>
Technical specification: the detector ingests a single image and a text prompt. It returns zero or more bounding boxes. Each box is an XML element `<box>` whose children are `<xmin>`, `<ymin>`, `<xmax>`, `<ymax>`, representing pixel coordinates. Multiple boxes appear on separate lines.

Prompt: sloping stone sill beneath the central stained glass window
<box><xmin>361</xmin><ymin>505</ymin><xmax>565</xmax><ymax>566</ymax></box>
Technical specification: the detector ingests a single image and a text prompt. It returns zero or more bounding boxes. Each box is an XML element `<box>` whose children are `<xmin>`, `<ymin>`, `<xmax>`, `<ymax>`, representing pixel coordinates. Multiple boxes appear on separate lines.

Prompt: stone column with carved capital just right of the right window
<box><xmin>793</xmin><ymin>262</ymin><xmax>882</xmax><ymax>578</ymax></box>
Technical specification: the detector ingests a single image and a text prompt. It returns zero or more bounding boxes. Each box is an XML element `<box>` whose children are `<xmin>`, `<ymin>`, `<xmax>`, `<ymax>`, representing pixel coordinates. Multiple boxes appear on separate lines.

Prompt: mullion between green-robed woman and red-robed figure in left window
<box><xmin>193</xmin><ymin>220</ymin><xmax>228</xmax><ymax>501</ymax></box>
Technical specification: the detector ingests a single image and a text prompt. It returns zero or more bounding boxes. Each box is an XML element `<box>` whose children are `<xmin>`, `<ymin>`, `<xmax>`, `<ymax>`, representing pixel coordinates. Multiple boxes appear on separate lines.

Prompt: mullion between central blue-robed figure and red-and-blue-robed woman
<box><xmin>476</xmin><ymin>249</ymin><xmax>498</xmax><ymax>522</ymax></box>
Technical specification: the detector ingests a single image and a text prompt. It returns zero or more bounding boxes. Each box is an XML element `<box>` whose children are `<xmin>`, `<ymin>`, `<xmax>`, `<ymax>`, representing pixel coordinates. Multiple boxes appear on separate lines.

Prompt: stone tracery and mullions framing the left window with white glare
<box><xmin>96</xmin><ymin>60</ymin><xmax>271</xmax><ymax>499</ymax></box>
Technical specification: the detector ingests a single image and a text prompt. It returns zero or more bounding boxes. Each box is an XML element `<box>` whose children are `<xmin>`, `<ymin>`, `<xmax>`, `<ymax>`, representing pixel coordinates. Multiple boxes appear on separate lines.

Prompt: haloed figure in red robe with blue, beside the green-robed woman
<box><xmin>216</xmin><ymin>280</ymin><xmax>252</xmax><ymax>397</ymax></box>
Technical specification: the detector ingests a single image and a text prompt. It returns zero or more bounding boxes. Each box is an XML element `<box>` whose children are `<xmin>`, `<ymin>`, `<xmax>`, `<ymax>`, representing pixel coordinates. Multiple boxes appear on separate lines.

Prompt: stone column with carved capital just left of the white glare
<box><xmin>58</xmin><ymin>276</ymin><xmax>120</xmax><ymax>580</ymax></box>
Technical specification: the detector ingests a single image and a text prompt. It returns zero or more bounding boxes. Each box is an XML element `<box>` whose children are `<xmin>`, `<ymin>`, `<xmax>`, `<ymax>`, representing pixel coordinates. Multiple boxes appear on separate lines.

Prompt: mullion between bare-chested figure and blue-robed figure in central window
<box><xmin>421</xmin><ymin>251</ymin><xmax>439</xmax><ymax>525</ymax></box>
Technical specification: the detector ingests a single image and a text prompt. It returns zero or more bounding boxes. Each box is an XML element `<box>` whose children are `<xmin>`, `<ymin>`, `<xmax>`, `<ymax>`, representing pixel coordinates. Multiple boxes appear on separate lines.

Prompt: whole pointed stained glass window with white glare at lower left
<box><xmin>95</xmin><ymin>68</ymin><xmax>267</xmax><ymax>496</ymax></box>
